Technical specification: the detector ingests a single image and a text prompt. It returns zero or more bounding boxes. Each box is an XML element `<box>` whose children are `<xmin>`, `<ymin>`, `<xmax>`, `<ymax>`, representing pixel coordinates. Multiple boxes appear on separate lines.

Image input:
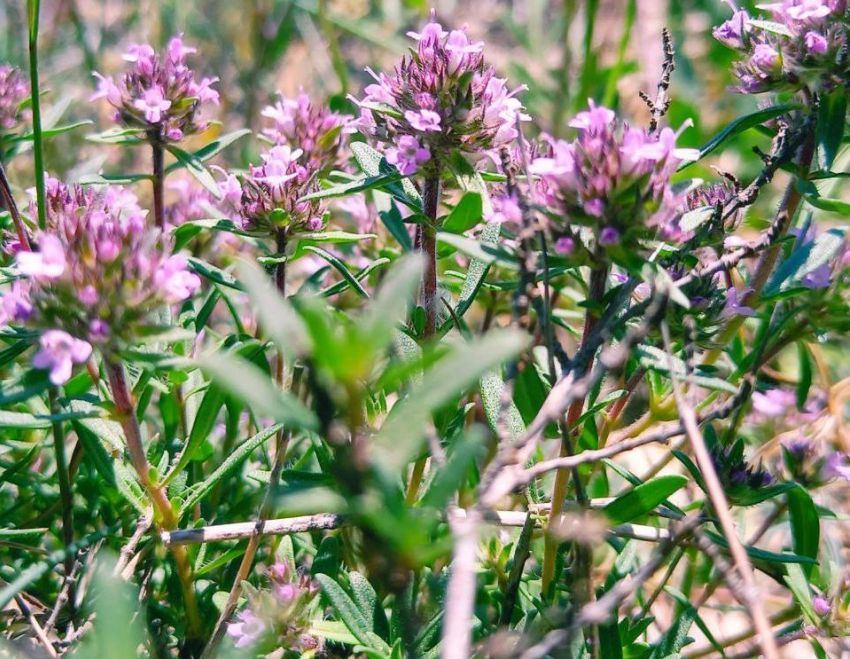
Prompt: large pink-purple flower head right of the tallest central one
<box><xmin>530</xmin><ymin>101</ymin><xmax>698</xmax><ymax>253</ymax></box>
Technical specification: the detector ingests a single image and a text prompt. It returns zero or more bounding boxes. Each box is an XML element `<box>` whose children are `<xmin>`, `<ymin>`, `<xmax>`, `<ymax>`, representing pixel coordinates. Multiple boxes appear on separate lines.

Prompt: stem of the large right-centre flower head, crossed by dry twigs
<box><xmin>542</xmin><ymin>266</ymin><xmax>608</xmax><ymax>593</ymax></box>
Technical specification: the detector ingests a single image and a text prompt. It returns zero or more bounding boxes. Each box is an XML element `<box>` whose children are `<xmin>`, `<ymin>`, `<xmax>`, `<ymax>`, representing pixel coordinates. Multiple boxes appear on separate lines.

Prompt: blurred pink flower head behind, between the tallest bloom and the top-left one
<box><xmin>262</xmin><ymin>93</ymin><xmax>356</xmax><ymax>171</ymax></box>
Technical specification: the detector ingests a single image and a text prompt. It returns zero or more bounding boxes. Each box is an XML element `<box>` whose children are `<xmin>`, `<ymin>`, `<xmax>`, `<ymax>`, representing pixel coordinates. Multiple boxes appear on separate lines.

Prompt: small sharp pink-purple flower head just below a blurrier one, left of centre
<box><xmin>225</xmin><ymin>145</ymin><xmax>325</xmax><ymax>236</ymax></box>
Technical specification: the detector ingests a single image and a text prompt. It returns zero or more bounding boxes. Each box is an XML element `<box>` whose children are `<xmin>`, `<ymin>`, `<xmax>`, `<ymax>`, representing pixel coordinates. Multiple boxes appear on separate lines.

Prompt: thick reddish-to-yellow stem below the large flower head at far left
<box><xmin>105</xmin><ymin>360</ymin><xmax>202</xmax><ymax>639</ymax></box>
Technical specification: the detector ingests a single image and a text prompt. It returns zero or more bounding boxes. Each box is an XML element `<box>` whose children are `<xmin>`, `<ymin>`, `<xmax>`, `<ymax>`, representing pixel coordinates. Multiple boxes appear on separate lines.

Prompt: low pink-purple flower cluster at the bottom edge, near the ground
<box><xmin>227</xmin><ymin>563</ymin><xmax>319</xmax><ymax>652</ymax></box>
